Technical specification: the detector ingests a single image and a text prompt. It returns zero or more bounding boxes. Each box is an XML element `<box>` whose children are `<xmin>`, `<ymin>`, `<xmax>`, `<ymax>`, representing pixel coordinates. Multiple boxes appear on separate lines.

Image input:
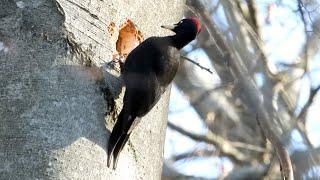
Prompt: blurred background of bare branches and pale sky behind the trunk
<box><xmin>162</xmin><ymin>0</ymin><xmax>320</xmax><ymax>179</ymax></box>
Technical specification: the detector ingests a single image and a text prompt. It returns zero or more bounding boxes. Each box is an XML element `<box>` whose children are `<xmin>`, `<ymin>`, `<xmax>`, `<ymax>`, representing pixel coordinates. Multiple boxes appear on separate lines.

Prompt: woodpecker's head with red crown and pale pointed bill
<box><xmin>161</xmin><ymin>17</ymin><xmax>201</xmax><ymax>37</ymax></box>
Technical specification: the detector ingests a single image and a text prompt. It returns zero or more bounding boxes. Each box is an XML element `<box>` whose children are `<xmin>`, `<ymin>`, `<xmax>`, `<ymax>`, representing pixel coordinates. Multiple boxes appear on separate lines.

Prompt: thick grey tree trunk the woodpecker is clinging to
<box><xmin>0</xmin><ymin>0</ymin><xmax>183</xmax><ymax>179</ymax></box>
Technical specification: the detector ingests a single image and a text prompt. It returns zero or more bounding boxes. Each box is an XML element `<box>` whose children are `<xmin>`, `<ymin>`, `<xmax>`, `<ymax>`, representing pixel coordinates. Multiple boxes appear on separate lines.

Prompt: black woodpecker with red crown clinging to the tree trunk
<box><xmin>107</xmin><ymin>18</ymin><xmax>201</xmax><ymax>169</ymax></box>
